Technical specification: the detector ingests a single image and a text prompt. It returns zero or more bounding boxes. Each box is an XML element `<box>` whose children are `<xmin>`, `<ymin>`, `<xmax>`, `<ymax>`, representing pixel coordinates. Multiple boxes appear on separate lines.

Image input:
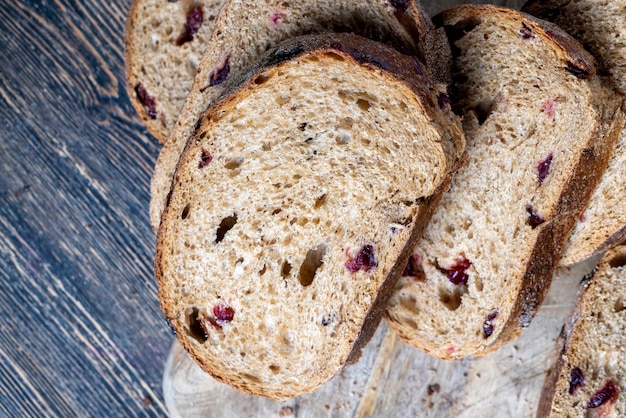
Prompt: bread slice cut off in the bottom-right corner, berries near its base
<box><xmin>537</xmin><ymin>246</ymin><xmax>626</xmax><ymax>418</ymax></box>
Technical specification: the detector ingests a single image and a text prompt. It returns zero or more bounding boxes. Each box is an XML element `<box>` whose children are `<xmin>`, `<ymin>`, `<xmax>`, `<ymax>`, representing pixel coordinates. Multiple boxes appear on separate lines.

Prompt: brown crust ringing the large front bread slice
<box><xmin>155</xmin><ymin>34</ymin><xmax>464</xmax><ymax>399</ymax></box>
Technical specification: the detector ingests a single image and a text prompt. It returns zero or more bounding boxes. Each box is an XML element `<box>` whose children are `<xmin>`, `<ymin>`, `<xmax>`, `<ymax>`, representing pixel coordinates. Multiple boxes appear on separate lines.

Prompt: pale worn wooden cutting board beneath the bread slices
<box><xmin>158</xmin><ymin>0</ymin><xmax>598</xmax><ymax>418</ymax></box>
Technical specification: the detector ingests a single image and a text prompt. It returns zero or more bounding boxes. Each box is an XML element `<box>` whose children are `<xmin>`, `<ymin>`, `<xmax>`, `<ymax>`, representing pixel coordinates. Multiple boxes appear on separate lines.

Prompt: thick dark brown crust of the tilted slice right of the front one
<box><xmin>433</xmin><ymin>5</ymin><xmax>624</xmax><ymax>355</ymax></box>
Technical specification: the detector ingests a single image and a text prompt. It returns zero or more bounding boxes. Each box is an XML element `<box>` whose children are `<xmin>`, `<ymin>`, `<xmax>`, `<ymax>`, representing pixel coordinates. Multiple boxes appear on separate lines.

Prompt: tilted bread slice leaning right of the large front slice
<box><xmin>386</xmin><ymin>5</ymin><xmax>623</xmax><ymax>358</ymax></box>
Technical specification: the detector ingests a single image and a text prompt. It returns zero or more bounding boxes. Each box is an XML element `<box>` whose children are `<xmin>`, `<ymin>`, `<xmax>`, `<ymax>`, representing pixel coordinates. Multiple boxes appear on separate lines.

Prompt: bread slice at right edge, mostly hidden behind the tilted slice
<box><xmin>524</xmin><ymin>0</ymin><xmax>626</xmax><ymax>266</ymax></box>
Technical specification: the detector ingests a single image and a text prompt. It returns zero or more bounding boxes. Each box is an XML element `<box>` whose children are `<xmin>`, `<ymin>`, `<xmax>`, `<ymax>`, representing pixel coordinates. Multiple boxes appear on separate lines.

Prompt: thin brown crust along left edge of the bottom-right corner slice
<box><xmin>536</xmin><ymin>246</ymin><xmax>626</xmax><ymax>418</ymax></box>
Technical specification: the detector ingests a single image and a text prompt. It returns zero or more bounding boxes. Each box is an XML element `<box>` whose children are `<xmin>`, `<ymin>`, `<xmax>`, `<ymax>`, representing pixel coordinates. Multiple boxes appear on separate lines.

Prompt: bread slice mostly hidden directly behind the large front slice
<box><xmin>150</xmin><ymin>0</ymin><xmax>451</xmax><ymax>231</ymax></box>
